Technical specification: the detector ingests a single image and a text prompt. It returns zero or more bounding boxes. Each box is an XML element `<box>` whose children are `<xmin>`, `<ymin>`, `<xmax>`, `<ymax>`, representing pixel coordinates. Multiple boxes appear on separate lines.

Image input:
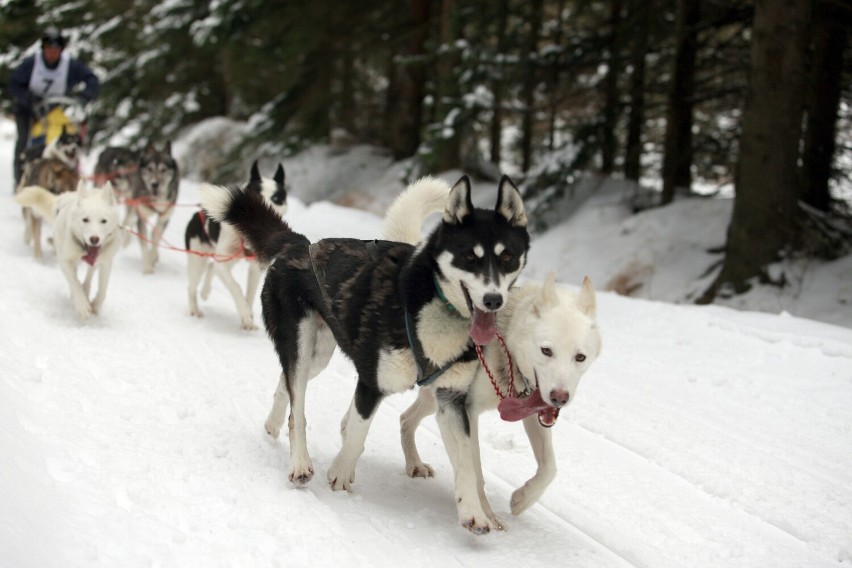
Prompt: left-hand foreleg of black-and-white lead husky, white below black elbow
<box><xmin>328</xmin><ymin>382</ymin><xmax>383</xmax><ymax>492</ymax></box>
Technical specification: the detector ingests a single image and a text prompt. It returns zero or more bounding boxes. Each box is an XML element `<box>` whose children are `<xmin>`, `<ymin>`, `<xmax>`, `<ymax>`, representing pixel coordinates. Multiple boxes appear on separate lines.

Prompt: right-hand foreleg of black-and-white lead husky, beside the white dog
<box><xmin>436</xmin><ymin>389</ymin><xmax>497</xmax><ymax>534</ymax></box>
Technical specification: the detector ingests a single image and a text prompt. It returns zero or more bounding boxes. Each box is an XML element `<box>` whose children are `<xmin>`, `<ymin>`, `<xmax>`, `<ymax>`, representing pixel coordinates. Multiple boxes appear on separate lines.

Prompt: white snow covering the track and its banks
<box><xmin>5</xmin><ymin>116</ymin><xmax>852</xmax><ymax>568</ymax></box>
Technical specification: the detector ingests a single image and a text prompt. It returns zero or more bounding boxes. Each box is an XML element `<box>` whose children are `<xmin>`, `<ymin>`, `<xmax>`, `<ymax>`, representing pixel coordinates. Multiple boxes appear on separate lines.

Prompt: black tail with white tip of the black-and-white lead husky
<box><xmin>198</xmin><ymin>183</ymin><xmax>293</xmax><ymax>264</ymax></box>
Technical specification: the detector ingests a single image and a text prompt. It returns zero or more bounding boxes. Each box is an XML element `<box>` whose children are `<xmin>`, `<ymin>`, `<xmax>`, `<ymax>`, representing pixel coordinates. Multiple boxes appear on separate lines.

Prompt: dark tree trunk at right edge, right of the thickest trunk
<box><xmin>802</xmin><ymin>4</ymin><xmax>846</xmax><ymax>211</ymax></box>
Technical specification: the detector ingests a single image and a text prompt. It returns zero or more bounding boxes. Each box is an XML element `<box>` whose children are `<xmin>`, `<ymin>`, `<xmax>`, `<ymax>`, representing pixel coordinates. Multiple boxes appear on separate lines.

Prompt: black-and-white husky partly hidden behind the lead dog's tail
<box><xmin>184</xmin><ymin>161</ymin><xmax>287</xmax><ymax>330</ymax></box>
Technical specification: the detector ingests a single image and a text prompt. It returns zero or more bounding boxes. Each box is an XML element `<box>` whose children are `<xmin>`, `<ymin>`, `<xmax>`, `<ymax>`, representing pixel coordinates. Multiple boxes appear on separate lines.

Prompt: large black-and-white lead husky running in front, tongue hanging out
<box><xmin>199</xmin><ymin>176</ymin><xmax>529</xmax><ymax>532</ymax></box>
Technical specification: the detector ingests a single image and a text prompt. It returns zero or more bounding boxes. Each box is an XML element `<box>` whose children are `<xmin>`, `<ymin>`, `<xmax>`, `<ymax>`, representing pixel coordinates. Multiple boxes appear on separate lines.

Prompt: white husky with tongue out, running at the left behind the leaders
<box><xmin>15</xmin><ymin>181</ymin><xmax>121</xmax><ymax>319</ymax></box>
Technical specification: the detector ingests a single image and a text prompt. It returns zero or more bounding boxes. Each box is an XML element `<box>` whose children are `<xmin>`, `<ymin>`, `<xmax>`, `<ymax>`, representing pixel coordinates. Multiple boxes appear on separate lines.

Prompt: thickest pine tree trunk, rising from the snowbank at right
<box><xmin>700</xmin><ymin>0</ymin><xmax>812</xmax><ymax>301</ymax></box>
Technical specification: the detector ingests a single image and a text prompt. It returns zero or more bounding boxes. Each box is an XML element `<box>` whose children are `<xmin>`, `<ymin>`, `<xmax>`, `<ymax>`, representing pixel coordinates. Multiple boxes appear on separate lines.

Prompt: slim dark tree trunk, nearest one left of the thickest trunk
<box><xmin>662</xmin><ymin>0</ymin><xmax>701</xmax><ymax>204</ymax></box>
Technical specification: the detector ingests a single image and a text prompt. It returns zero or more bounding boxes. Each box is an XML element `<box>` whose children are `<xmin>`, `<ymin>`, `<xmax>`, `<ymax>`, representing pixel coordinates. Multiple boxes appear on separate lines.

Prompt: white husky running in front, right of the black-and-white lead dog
<box><xmin>384</xmin><ymin>179</ymin><xmax>601</xmax><ymax>532</ymax></box>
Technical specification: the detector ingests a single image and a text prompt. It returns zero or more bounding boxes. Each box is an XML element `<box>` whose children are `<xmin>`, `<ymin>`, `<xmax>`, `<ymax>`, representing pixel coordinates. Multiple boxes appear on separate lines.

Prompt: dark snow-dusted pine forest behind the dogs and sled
<box><xmin>0</xmin><ymin>0</ymin><xmax>852</xmax><ymax>302</ymax></box>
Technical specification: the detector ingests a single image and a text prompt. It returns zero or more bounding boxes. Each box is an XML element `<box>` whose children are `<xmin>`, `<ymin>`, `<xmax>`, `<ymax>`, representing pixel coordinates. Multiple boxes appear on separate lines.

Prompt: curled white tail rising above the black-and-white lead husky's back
<box><xmin>384</xmin><ymin>176</ymin><xmax>450</xmax><ymax>245</ymax></box>
